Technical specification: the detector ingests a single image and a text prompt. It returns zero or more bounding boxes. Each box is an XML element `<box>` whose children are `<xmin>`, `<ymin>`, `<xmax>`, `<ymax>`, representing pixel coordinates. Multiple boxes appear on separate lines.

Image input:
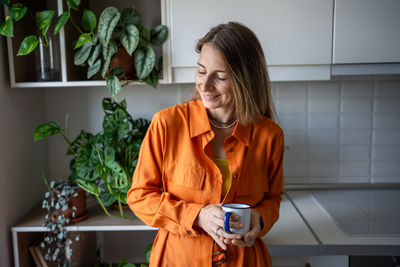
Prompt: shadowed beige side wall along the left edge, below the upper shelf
<box><xmin>0</xmin><ymin>37</ymin><xmax>46</xmax><ymax>267</ymax></box>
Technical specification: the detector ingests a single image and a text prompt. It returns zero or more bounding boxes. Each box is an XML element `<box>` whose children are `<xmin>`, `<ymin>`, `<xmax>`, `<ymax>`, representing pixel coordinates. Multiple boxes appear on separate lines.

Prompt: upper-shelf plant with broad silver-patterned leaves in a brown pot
<box><xmin>74</xmin><ymin>7</ymin><xmax>168</xmax><ymax>96</ymax></box>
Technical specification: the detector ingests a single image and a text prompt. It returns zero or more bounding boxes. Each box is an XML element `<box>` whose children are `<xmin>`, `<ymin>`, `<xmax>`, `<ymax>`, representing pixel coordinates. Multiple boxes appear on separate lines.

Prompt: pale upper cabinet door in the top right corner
<box><xmin>333</xmin><ymin>0</ymin><xmax>400</xmax><ymax>64</ymax></box>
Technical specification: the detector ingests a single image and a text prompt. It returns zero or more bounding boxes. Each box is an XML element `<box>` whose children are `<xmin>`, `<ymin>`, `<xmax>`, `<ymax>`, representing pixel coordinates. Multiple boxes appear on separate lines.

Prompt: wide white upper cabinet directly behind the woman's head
<box><xmin>164</xmin><ymin>0</ymin><xmax>333</xmax><ymax>83</ymax></box>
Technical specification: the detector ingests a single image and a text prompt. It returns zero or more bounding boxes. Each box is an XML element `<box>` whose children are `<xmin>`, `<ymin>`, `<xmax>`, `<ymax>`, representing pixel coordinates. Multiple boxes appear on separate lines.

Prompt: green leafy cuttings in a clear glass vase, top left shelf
<box><xmin>0</xmin><ymin>0</ymin><xmax>96</xmax><ymax>81</ymax></box>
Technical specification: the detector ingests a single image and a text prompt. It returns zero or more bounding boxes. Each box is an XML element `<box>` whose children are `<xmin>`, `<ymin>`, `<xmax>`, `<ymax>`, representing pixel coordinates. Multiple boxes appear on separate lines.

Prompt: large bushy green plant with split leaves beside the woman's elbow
<box><xmin>34</xmin><ymin>98</ymin><xmax>149</xmax><ymax>218</ymax></box>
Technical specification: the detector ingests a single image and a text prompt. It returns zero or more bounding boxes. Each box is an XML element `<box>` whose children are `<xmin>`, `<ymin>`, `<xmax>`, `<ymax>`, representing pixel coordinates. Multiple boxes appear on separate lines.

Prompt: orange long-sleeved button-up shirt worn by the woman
<box><xmin>127</xmin><ymin>100</ymin><xmax>283</xmax><ymax>267</ymax></box>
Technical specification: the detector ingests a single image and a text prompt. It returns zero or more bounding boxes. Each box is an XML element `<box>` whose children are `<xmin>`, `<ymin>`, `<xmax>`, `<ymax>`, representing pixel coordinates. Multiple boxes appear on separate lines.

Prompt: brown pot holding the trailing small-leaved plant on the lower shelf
<box><xmin>52</xmin><ymin>188</ymin><xmax>87</xmax><ymax>224</ymax></box>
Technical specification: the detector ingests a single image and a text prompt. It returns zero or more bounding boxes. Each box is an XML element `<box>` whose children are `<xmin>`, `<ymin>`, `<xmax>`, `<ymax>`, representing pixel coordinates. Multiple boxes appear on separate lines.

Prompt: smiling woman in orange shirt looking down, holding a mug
<box><xmin>128</xmin><ymin>22</ymin><xmax>283</xmax><ymax>267</ymax></box>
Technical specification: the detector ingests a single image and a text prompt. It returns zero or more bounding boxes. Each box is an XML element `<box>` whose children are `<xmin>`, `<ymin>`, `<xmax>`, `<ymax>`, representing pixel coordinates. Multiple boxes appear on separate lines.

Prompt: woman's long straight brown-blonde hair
<box><xmin>196</xmin><ymin>22</ymin><xmax>276</xmax><ymax>125</ymax></box>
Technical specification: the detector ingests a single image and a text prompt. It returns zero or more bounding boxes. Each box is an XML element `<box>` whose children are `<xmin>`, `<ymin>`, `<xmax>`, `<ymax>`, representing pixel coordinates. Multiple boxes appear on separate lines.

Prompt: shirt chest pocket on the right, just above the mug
<box><xmin>236</xmin><ymin>173</ymin><xmax>269</xmax><ymax>196</ymax></box>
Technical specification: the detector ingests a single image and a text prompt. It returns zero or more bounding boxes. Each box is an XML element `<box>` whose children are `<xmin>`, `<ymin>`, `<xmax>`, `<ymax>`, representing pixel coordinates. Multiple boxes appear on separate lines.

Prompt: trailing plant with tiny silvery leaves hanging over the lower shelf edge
<box><xmin>40</xmin><ymin>176</ymin><xmax>82</xmax><ymax>267</ymax></box>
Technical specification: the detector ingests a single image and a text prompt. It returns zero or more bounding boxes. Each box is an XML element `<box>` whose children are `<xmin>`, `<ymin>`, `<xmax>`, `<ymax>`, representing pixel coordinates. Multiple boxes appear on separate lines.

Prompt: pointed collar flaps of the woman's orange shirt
<box><xmin>189</xmin><ymin>100</ymin><xmax>252</xmax><ymax>146</ymax></box>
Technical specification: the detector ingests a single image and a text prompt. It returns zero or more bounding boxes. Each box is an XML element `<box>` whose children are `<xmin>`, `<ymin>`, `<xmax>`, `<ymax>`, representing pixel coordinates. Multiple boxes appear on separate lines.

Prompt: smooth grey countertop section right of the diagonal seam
<box><xmin>287</xmin><ymin>189</ymin><xmax>400</xmax><ymax>255</ymax></box>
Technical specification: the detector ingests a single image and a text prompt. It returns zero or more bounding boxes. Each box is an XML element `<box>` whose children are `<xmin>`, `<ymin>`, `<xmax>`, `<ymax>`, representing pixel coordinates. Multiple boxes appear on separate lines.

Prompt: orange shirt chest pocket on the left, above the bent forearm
<box><xmin>164</xmin><ymin>163</ymin><xmax>206</xmax><ymax>190</ymax></box>
